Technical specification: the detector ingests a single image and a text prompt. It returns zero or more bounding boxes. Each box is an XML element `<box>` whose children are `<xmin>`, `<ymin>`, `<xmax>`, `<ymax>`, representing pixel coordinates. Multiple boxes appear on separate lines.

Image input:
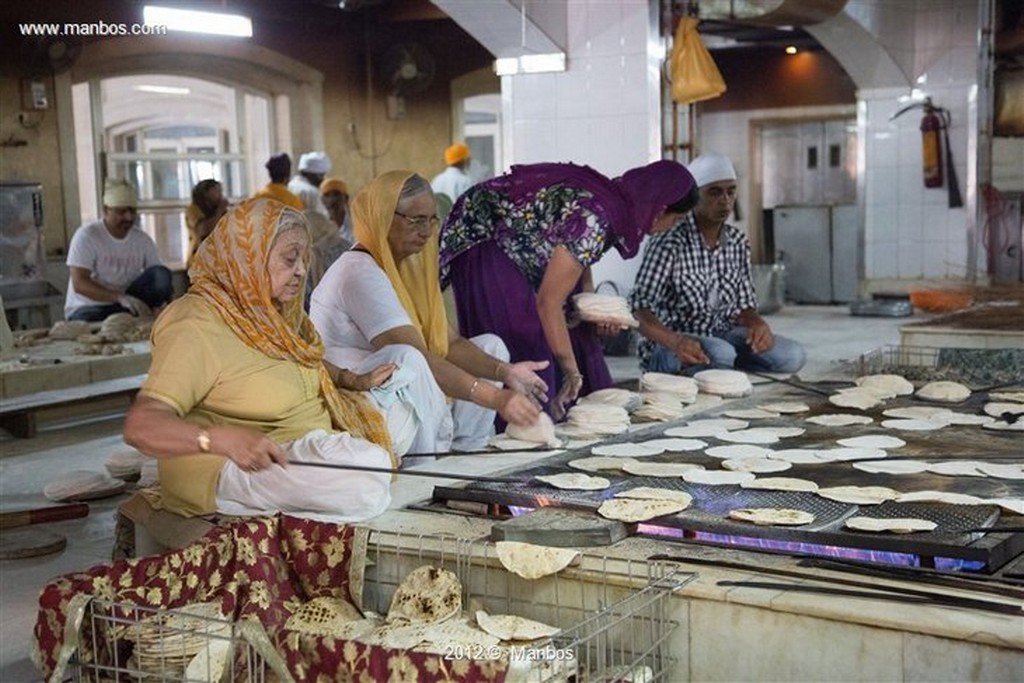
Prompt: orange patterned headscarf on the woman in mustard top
<box><xmin>188</xmin><ymin>199</ymin><xmax>394</xmax><ymax>462</ymax></box>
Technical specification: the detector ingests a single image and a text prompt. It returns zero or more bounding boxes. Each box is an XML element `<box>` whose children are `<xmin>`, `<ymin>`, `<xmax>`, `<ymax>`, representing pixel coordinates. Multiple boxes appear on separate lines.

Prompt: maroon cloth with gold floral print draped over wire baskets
<box><xmin>32</xmin><ymin>515</ymin><xmax>507</xmax><ymax>683</ymax></box>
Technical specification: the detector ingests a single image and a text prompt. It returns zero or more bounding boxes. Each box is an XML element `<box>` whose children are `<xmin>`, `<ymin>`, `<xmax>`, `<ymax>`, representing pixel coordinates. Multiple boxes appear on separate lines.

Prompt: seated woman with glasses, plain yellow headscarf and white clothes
<box><xmin>309</xmin><ymin>171</ymin><xmax>547</xmax><ymax>453</ymax></box>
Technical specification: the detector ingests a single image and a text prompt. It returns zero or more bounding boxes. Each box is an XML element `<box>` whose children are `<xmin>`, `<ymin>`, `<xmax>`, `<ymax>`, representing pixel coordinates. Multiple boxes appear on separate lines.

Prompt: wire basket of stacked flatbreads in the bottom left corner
<box><xmin>50</xmin><ymin>596</ymin><xmax>294</xmax><ymax>683</ymax></box>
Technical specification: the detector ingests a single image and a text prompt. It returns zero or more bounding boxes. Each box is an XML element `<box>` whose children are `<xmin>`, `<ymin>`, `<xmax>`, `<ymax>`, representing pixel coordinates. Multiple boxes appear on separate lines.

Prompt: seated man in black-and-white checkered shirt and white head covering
<box><xmin>631</xmin><ymin>153</ymin><xmax>806</xmax><ymax>375</ymax></box>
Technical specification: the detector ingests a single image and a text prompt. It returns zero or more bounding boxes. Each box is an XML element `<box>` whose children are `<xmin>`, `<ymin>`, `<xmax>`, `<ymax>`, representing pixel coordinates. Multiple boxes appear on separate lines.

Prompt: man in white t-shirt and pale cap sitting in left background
<box><xmin>65</xmin><ymin>179</ymin><xmax>173</xmax><ymax>322</ymax></box>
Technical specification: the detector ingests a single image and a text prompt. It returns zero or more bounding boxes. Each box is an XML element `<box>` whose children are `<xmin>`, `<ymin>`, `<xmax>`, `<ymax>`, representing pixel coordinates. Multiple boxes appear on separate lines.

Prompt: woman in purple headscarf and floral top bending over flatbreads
<box><xmin>440</xmin><ymin>161</ymin><xmax>695</xmax><ymax>419</ymax></box>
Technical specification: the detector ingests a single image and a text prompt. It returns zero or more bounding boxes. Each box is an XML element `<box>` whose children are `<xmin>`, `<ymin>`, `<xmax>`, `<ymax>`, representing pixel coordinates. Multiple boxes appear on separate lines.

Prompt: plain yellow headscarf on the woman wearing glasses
<box><xmin>352</xmin><ymin>171</ymin><xmax>449</xmax><ymax>357</ymax></box>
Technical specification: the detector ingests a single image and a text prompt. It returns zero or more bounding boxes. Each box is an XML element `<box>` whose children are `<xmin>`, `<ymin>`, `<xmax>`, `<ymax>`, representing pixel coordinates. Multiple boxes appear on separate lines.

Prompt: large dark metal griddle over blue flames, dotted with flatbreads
<box><xmin>434</xmin><ymin>391</ymin><xmax>1024</xmax><ymax>571</ymax></box>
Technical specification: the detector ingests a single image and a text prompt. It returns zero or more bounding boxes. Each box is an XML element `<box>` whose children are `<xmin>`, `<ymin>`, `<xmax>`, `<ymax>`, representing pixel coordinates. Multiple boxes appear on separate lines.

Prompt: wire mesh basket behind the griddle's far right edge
<box><xmin>848</xmin><ymin>345</ymin><xmax>1024</xmax><ymax>388</ymax></box>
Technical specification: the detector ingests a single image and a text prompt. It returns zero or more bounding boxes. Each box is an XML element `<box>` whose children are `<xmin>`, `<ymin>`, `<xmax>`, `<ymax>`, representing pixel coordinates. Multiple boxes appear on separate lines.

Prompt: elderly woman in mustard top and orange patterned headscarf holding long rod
<box><xmin>124</xmin><ymin>199</ymin><xmax>396</xmax><ymax>521</ymax></box>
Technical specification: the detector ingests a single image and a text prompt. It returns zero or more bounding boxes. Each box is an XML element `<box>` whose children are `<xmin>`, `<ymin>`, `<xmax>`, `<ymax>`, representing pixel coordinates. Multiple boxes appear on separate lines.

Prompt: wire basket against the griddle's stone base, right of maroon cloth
<box><xmin>364</xmin><ymin>532</ymin><xmax>694</xmax><ymax>683</ymax></box>
